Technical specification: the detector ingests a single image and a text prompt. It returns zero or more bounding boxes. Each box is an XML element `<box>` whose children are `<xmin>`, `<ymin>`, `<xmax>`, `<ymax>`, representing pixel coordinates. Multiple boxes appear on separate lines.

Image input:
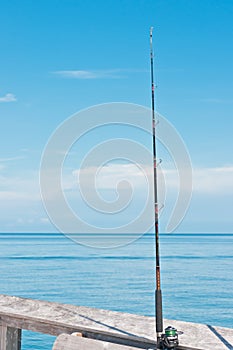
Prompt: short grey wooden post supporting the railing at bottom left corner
<box><xmin>0</xmin><ymin>324</ymin><xmax>21</xmax><ymax>350</ymax></box>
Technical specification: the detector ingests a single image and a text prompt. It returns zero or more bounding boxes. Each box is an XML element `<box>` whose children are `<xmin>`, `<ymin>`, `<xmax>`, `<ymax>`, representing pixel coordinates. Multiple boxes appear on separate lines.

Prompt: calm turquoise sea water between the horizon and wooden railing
<box><xmin>0</xmin><ymin>234</ymin><xmax>233</xmax><ymax>350</ymax></box>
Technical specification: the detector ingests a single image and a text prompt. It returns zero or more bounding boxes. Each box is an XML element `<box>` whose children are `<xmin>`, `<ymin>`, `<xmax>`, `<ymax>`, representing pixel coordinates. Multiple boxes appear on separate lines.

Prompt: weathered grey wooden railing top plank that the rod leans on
<box><xmin>0</xmin><ymin>295</ymin><xmax>233</xmax><ymax>350</ymax></box>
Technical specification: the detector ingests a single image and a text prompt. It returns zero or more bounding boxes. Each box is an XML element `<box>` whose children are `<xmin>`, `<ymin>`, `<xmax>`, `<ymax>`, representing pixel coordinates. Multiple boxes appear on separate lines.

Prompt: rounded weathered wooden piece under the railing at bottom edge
<box><xmin>52</xmin><ymin>334</ymin><xmax>138</xmax><ymax>350</ymax></box>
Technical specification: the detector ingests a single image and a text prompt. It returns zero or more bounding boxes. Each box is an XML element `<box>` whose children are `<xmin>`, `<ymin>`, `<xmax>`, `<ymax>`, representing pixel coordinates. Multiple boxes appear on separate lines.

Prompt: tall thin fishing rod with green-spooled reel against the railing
<box><xmin>150</xmin><ymin>27</ymin><xmax>178</xmax><ymax>350</ymax></box>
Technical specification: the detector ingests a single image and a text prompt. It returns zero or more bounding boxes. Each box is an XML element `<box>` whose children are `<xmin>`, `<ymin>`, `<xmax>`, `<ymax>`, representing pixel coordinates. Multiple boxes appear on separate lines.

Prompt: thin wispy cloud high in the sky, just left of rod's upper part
<box><xmin>53</xmin><ymin>68</ymin><xmax>145</xmax><ymax>79</ymax></box>
